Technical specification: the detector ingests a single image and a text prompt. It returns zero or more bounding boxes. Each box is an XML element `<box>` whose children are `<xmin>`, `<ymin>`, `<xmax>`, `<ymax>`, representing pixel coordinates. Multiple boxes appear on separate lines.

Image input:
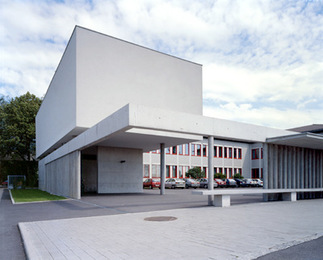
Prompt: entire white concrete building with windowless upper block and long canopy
<box><xmin>36</xmin><ymin>26</ymin><xmax>323</xmax><ymax>198</ymax></box>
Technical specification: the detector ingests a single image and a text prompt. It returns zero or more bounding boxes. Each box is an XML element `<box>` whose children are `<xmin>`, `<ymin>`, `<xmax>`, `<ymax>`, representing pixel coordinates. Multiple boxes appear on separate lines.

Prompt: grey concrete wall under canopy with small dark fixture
<box><xmin>98</xmin><ymin>147</ymin><xmax>143</xmax><ymax>193</ymax></box>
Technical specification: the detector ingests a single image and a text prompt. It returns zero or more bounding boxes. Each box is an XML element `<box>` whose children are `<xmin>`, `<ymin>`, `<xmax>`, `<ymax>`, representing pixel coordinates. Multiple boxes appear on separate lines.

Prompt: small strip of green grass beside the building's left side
<box><xmin>11</xmin><ymin>189</ymin><xmax>66</xmax><ymax>202</ymax></box>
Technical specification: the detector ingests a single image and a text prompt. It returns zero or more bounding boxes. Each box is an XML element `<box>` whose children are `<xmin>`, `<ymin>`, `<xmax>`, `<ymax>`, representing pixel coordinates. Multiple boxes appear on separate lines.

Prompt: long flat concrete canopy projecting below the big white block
<box><xmin>45</xmin><ymin>104</ymin><xmax>293</xmax><ymax>162</ymax></box>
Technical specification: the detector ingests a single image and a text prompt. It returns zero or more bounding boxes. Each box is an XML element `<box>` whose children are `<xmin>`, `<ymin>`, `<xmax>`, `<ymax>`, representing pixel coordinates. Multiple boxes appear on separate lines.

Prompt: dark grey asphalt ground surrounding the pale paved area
<box><xmin>0</xmin><ymin>188</ymin><xmax>323</xmax><ymax>260</ymax></box>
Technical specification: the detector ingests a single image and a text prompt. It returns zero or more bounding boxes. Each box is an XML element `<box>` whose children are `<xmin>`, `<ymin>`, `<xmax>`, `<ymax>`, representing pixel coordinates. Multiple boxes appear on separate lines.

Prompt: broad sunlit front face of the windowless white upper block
<box><xmin>76</xmin><ymin>27</ymin><xmax>203</xmax><ymax>127</ymax></box>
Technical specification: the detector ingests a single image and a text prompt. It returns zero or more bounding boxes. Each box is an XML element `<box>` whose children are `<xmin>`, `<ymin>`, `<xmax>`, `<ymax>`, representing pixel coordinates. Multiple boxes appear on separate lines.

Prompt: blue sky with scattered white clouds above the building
<box><xmin>0</xmin><ymin>0</ymin><xmax>323</xmax><ymax>129</ymax></box>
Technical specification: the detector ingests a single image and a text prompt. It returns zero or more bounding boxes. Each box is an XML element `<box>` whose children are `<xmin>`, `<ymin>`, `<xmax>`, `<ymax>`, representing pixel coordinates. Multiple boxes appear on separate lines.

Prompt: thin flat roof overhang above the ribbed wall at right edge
<box><xmin>266</xmin><ymin>133</ymin><xmax>323</xmax><ymax>150</ymax></box>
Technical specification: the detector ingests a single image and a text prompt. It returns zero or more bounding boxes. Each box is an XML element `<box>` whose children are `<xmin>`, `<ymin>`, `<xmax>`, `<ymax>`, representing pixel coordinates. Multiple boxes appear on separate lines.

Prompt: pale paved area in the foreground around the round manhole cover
<box><xmin>19</xmin><ymin>199</ymin><xmax>323</xmax><ymax>260</ymax></box>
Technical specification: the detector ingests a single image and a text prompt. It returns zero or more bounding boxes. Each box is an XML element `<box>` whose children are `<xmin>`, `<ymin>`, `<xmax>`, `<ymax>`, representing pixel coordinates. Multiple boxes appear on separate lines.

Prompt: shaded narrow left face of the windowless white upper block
<box><xmin>36</xmin><ymin>31</ymin><xmax>77</xmax><ymax>157</ymax></box>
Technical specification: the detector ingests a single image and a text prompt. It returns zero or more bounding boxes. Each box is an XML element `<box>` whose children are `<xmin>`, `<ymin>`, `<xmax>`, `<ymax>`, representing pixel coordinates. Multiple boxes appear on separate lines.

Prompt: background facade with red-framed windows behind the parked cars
<box><xmin>143</xmin><ymin>139</ymin><xmax>263</xmax><ymax>178</ymax></box>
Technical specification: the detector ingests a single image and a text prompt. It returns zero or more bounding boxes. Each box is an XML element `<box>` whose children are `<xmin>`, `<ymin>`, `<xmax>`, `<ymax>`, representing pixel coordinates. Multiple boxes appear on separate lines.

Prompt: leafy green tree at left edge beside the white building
<box><xmin>0</xmin><ymin>92</ymin><xmax>42</xmax><ymax>161</ymax></box>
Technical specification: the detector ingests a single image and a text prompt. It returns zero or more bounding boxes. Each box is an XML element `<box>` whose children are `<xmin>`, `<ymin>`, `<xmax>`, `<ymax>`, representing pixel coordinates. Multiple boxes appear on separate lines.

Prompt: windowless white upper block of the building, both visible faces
<box><xmin>36</xmin><ymin>27</ymin><xmax>203</xmax><ymax>157</ymax></box>
